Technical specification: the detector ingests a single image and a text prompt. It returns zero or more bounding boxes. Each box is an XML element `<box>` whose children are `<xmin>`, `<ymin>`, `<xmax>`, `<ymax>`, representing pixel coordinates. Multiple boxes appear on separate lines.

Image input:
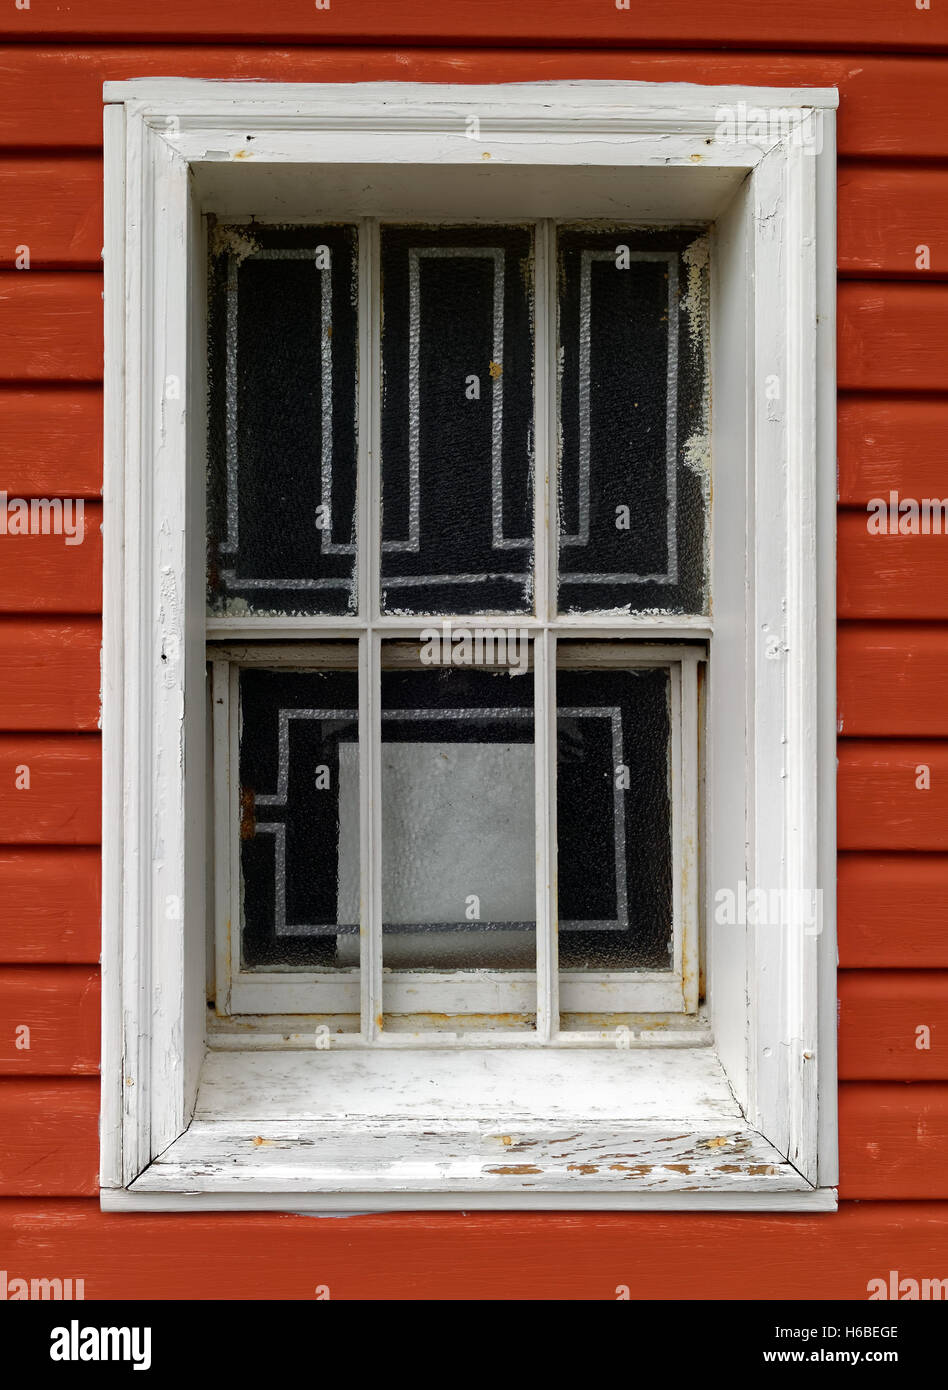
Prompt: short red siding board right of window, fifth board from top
<box><xmin>837</xmin><ymin>396</ymin><xmax>948</xmax><ymax>507</ymax></box>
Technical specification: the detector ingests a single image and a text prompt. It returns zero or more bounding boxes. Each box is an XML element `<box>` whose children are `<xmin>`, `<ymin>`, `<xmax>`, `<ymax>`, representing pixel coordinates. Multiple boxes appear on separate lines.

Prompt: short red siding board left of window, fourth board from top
<box><xmin>0</xmin><ymin>270</ymin><xmax>103</xmax><ymax>381</ymax></box>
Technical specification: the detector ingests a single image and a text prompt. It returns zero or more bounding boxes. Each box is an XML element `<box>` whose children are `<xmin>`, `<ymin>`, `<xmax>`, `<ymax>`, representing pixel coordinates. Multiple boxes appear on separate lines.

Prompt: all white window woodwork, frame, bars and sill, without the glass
<box><xmin>103</xmin><ymin>82</ymin><xmax>834</xmax><ymax>1209</ymax></box>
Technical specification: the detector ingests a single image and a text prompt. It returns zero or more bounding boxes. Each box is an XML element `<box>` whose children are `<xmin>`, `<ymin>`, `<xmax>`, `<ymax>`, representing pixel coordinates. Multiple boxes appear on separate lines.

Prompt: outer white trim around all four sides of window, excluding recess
<box><xmin>100</xmin><ymin>79</ymin><xmax>837</xmax><ymax>1209</ymax></box>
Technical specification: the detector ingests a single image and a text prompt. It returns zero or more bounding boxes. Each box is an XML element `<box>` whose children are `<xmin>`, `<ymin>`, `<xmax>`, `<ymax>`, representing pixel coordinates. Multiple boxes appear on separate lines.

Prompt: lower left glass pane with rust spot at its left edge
<box><xmin>239</xmin><ymin>658</ymin><xmax>359</xmax><ymax>970</ymax></box>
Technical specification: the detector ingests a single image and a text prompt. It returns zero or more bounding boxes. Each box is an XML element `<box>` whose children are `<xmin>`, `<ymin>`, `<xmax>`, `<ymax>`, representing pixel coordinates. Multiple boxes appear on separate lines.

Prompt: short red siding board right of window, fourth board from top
<box><xmin>837</xmin><ymin>281</ymin><xmax>948</xmax><ymax>391</ymax></box>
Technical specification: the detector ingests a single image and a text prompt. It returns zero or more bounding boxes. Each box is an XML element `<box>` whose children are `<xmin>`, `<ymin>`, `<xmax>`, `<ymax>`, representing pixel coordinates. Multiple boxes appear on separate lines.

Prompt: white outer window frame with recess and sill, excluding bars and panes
<box><xmin>100</xmin><ymin>79</ymin><xmax>837</xmax><ymax>1211</ymax></box>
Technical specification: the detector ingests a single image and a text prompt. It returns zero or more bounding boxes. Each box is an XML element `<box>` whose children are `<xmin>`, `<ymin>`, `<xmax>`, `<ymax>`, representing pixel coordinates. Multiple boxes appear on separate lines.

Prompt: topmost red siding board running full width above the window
<box><xmin>0</xmin><ymin>0</ymin><xmax>948</xmax><ymax>50</ymax></box>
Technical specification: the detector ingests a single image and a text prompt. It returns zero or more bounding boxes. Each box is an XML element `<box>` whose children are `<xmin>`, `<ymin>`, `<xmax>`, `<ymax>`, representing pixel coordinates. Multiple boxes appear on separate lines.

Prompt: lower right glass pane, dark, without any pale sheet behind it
<box><xmin>556</xmin><ymin>658</ymin><xmax>673</xmax><ymax>970</ymax></box>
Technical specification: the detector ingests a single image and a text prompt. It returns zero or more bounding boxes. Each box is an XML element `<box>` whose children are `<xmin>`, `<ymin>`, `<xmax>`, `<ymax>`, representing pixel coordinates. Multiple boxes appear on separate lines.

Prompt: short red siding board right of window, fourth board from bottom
<box><xmin>837</xmin><ymin>853</ymin><xmax>948</xmax><ymax>970</ymax></box>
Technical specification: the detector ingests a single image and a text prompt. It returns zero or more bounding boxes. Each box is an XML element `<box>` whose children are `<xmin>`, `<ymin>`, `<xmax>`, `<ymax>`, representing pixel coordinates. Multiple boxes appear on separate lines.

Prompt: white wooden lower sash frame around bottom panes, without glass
<box><xmin>211</xmin><ymin>631</ymin><xmax>705</xmax><ymax>1047</ymax></box>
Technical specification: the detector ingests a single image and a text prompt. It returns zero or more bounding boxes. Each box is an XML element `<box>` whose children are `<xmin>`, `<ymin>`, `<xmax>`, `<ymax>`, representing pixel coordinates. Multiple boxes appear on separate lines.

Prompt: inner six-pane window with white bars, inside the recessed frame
<box><xmin>207</xmin><ymin>218</ymin><xmax>710</xmax><ymax>1023</ymax></box>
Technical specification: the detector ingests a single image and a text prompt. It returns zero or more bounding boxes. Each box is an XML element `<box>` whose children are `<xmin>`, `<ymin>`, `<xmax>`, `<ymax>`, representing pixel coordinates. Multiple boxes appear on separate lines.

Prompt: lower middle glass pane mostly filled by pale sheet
<box><xmin>382</xmin><ymin>644</ymin><xmax>537</xmax><ymax>967</ymax></box>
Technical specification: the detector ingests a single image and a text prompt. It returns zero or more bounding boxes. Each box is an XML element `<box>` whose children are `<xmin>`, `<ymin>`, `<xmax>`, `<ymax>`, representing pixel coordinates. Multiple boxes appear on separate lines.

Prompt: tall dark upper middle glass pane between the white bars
<box><xmin>381</xmin><ymin>227</ymin><xmax>534</xmax><ymax>613</ymax></box>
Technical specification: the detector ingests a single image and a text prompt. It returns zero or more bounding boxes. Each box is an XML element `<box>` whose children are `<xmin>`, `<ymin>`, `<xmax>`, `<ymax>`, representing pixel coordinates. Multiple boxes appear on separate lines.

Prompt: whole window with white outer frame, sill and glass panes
<box><xmin>103</xmin><ymin>81</ymin><xmax>834</xmax><ymax>1209</ymax></box>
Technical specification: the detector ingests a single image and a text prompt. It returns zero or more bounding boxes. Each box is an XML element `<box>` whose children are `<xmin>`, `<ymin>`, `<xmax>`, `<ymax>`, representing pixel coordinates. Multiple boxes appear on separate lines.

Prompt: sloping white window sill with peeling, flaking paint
<box><xmin>101</xmin><ymin>1047</ymin><xmax>835</xmax><ymax>1211</ymax></box>
